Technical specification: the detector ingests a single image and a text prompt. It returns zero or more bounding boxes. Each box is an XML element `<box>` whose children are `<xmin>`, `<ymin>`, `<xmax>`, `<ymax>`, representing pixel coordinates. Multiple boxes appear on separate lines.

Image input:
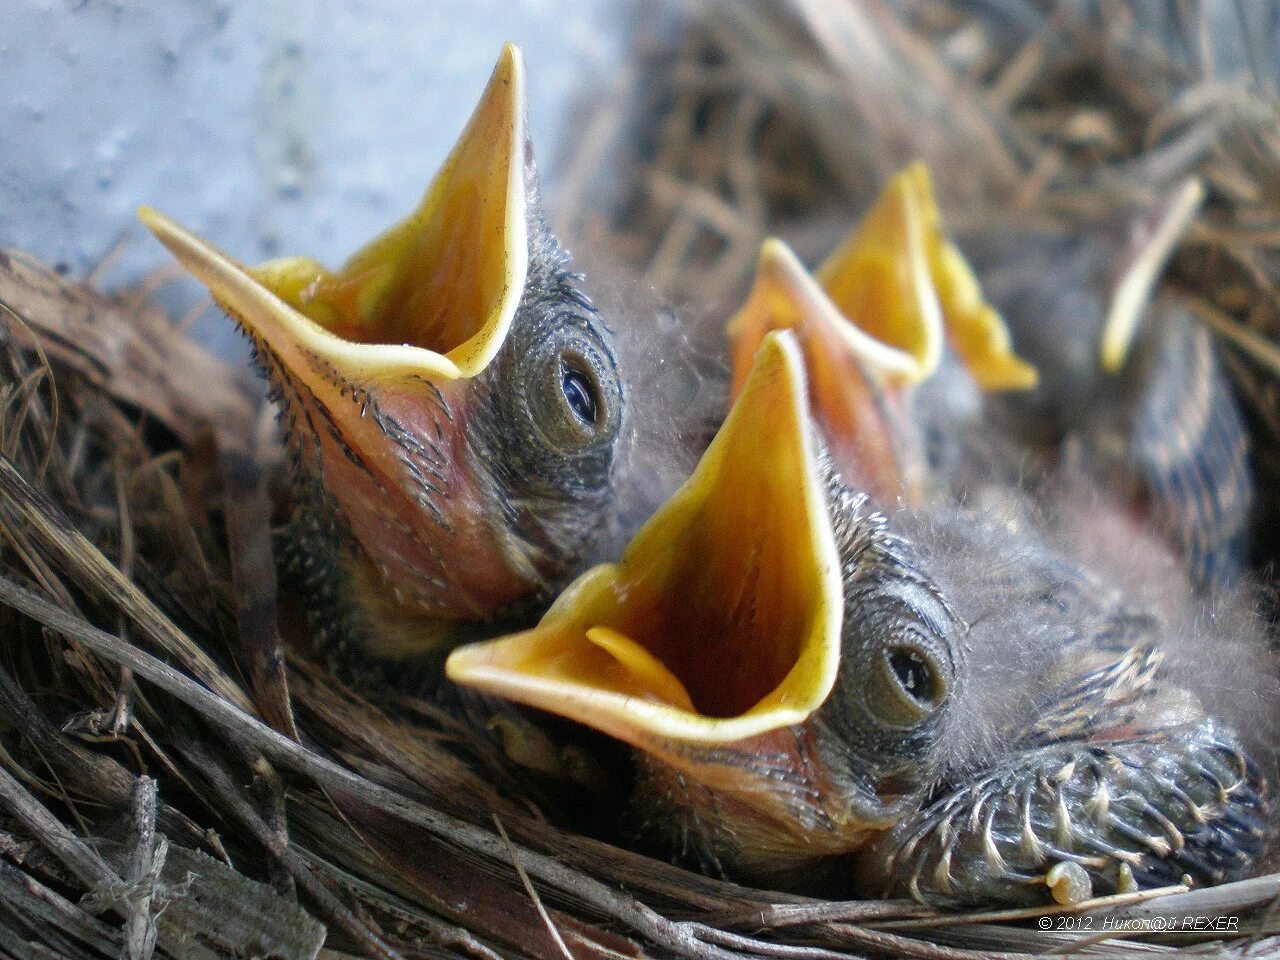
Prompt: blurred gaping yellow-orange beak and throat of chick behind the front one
<box><xmin>728</xmin><ymin>163</ymin><xmax>1036</xmax><ymax>503</ymax></box>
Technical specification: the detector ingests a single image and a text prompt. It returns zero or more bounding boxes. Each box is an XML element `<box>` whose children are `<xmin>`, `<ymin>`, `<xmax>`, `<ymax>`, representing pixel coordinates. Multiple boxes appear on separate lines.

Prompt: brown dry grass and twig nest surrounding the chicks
<box><xmin>0</xmin><ymin>0</ymin><xmax>1280</xmax><ymax>960</ymax></box>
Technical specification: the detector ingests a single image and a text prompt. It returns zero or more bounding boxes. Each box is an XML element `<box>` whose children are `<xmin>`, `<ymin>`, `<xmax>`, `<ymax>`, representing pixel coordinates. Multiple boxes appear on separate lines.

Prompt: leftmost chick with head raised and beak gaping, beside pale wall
<box><xmin>141</xmin><ymin>45</ymin><xmax>625</xmax><ymax>658</ymax></box>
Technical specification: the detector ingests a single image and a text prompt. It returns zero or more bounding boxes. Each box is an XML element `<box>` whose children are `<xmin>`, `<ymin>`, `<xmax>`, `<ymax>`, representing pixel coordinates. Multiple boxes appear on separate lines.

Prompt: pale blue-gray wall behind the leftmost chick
<box><xmin>0</xmin><ymin>0</ymin><xmax>630</xmax><ymax>350</ymax></box>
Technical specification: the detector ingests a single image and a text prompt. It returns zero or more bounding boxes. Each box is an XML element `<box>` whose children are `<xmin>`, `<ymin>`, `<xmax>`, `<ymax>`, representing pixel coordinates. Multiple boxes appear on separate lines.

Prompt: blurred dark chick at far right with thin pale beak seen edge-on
<box><xmin>960</xmin><ymin>179</ymin><xmax>1254</xmax><ymax>586</ymax></box>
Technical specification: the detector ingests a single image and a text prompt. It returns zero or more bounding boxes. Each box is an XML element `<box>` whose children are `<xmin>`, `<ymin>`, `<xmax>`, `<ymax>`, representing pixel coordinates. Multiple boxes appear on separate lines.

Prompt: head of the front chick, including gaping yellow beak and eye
<box><xmin>445</xmin><ymin>333</ymin><xmax>956</xmax><ymax>876</ymax></box>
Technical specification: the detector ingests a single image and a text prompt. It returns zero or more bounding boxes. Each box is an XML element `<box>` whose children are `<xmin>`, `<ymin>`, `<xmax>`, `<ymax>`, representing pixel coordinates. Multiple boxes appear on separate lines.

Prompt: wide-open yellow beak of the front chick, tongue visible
<box><xmin>445</xmin><ymin>333</ymin><xmax>842</xmax><ymax>764</ymax></box>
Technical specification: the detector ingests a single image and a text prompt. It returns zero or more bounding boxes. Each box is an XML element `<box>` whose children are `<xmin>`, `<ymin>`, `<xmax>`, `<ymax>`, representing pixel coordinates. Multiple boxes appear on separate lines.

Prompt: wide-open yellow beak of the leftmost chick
<box><xmin>138</xmin><ymin>44</ymin><xmax>530</xmax><ymax>379</ymax></box>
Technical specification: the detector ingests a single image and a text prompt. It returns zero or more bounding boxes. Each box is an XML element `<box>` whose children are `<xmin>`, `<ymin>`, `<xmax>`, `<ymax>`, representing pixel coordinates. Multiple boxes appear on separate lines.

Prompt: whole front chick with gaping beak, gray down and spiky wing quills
<box><xmin>447</xmin><ymin>332</ymin><xmax>1271</xmax><ymax>904</ymax></box>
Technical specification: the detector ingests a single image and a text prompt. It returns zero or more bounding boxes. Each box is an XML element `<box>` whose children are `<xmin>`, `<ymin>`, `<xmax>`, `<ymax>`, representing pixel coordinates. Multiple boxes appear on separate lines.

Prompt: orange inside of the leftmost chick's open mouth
<box><xmin>241</xmin><ymin>45</ymin><xmax>529</xmax><ymax>376</ymax></box>
